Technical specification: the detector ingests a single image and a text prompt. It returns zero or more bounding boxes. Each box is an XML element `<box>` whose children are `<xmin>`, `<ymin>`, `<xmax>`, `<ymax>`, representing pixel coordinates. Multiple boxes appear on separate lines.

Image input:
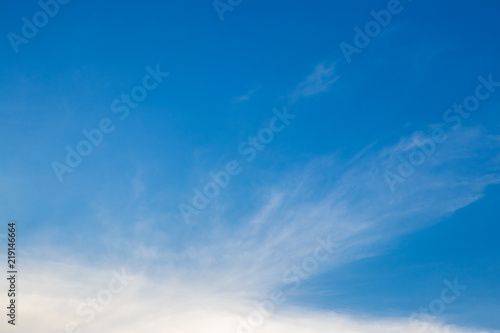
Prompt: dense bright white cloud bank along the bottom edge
<box><xmin>7</xmin><ymin>267</ymin><xmax>496</xmax><ymax>333</ymax></box>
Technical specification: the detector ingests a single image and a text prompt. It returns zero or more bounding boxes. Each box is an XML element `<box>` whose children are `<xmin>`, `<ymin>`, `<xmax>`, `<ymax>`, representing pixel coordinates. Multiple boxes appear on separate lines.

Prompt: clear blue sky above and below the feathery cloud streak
<box><xmin>0</xmin><ymin>0</ymin><xmax>500</xmax><ymax>329</ymax></box>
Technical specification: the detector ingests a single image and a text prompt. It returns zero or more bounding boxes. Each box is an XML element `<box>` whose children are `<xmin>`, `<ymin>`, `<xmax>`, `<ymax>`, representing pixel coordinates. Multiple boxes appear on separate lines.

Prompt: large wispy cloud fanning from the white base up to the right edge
<box><xmin>14</xmin><ymin>128</ymin><xmax>500</xmax><ymax>333</ymax></box>
